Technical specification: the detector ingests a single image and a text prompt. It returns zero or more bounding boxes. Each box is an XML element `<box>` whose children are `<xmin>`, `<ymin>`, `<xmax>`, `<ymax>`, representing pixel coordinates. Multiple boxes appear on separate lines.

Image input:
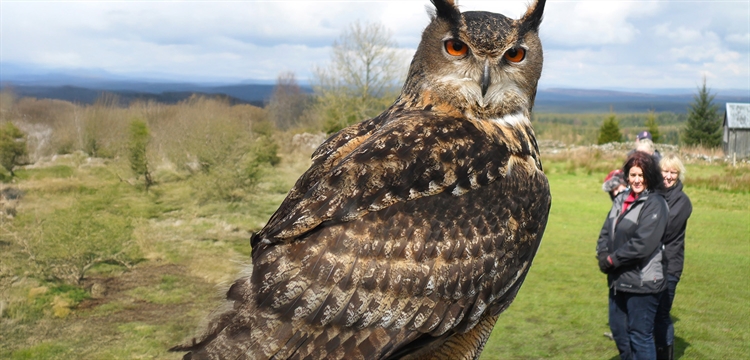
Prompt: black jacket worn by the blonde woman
<box><xmin>662</xmin><ymin>180</ymin><xmax>693</xmax><ymax>278</ymax></box>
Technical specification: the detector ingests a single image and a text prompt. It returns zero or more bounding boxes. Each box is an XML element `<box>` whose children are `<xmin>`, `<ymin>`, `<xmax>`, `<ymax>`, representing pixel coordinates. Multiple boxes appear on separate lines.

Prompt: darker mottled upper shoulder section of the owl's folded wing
<box><xmin>253</xmin><ymin>112</ymin><xmax>509</xmax><ymax>248</ymax></box>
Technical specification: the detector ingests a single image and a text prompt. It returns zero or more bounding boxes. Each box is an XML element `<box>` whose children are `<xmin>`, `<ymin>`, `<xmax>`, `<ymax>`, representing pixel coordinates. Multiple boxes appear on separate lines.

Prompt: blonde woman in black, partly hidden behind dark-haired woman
<box><xmin>654</xmin><ymin>154</ymin><xmax>693</xmax><ymax>360</ymax></box>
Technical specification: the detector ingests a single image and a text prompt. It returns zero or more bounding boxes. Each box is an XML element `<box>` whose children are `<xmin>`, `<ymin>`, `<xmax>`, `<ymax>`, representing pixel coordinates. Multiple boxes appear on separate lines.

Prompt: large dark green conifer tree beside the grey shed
<box><xmin>682</xmin><ymin>78</ymin><xmax>721</xmax><ymax>148</ymax></box>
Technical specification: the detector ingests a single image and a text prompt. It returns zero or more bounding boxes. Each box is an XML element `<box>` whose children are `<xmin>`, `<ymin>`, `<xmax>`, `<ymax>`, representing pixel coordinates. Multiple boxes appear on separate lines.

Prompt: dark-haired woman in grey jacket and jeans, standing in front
<box><xmin>596</xmin><ymin>151</ymin><xmax>669</xmax><ymax>360</ymax></box>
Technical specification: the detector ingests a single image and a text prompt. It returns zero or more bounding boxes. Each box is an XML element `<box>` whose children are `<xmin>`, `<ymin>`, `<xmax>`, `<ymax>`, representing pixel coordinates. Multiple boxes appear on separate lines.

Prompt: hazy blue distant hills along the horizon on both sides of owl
<box><xmin>0</xmin><ymin>64</ymin><xmax>750</xmax><ymax>113</ymax></box>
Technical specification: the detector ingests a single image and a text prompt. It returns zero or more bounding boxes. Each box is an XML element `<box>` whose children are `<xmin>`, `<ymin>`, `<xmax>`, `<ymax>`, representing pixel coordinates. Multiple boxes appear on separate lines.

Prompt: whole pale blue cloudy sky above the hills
<box><xmin>0</xmin><ymin>0</ymin><xmax>750</xmax><ymax>90</ymax></box>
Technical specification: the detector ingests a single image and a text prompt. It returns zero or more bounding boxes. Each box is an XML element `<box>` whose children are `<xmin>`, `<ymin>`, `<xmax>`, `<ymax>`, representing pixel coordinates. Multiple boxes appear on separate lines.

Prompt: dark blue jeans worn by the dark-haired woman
<box><xmin>609</xmin><ymin>289</ymin><xmax>661</xmax><ymax>360</ymax></box>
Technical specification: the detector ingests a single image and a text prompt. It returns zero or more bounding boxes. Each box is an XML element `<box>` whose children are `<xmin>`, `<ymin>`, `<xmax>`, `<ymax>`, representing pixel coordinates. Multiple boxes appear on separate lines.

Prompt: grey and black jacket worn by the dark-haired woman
<box><xmin>596</xmin><ymin>190</ymin><xmax>669</xmax><ymax>294</ymax></box>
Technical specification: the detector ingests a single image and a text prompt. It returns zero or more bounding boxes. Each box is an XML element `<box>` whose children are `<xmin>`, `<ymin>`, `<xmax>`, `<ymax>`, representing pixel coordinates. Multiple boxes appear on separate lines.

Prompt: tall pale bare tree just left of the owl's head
<box><xmin>314</xmin><ymin>22</ymin><xmax>407</xmax><ymax>132</ymax></box>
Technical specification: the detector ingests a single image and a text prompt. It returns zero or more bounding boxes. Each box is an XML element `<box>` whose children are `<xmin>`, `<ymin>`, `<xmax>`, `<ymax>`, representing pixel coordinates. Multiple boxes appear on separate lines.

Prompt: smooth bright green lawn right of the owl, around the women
<box><xmin>482</xmin><ymin>164</ymin><xmax>750</xmax><ymax>359</ymax></box>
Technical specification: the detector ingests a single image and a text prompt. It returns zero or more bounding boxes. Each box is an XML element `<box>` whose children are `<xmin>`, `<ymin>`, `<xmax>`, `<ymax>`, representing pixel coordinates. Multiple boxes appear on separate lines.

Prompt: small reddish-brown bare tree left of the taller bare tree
<box><xmin>267</xmin><ymin>72</ymin><xmax>308</xmax><ymax>130</ymax></box>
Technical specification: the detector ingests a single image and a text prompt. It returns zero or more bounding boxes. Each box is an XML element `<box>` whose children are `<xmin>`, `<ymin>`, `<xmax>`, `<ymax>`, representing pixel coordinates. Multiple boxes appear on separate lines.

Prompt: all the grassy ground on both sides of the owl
<box><xmin>0</xmin><ymin>153</ymin><xmax>750</xmax><ymax>359</ymax></box>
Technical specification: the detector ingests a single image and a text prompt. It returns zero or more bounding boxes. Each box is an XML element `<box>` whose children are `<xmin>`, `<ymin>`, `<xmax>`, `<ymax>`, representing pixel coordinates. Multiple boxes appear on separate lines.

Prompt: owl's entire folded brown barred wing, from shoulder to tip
<box><xmin>181</xmin><ymin>111</ymin><xmax>550</xmax><ymax>359</ymax></box>
